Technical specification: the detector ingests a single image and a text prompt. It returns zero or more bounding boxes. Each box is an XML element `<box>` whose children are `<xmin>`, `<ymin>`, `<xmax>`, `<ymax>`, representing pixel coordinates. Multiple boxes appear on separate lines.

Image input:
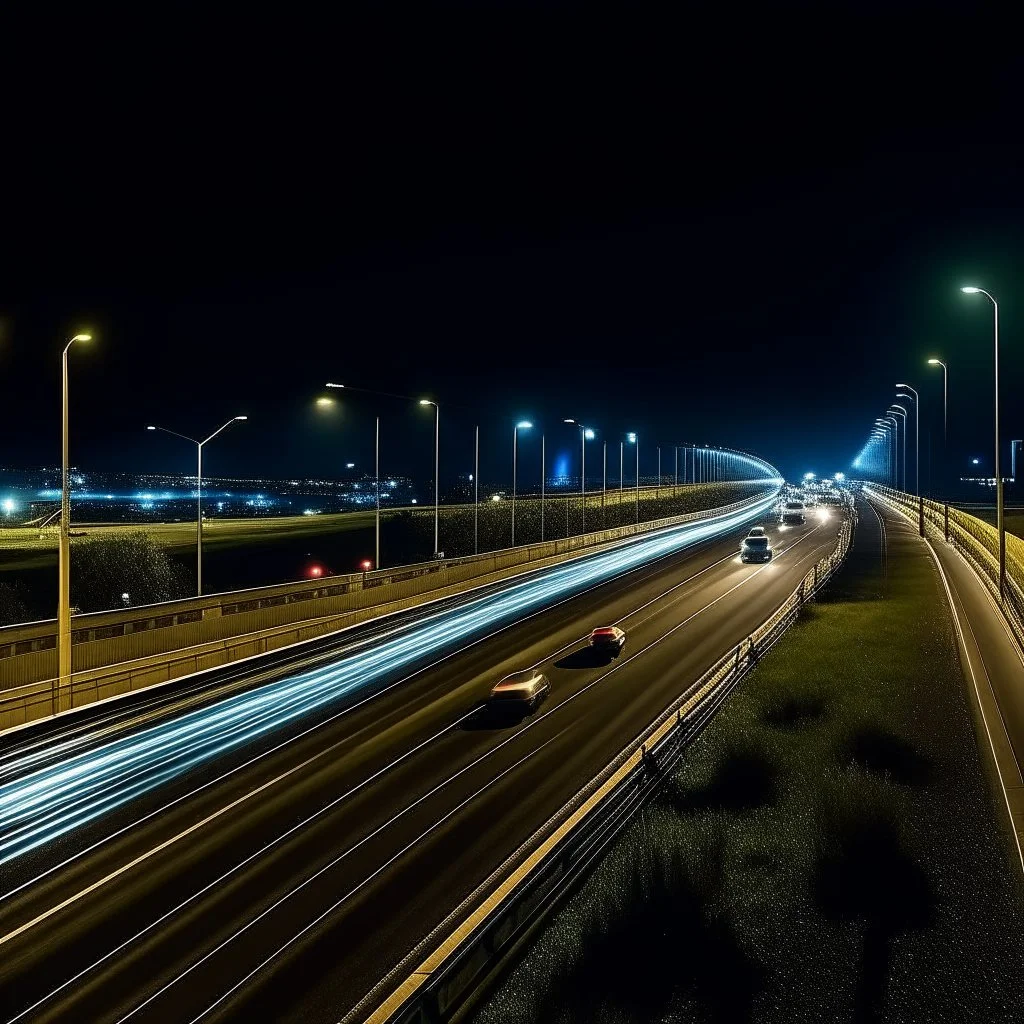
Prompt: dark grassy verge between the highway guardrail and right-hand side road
<box><xmin>474</xmin><ymin>505</ymin><xmax>1024</xmax><ymax>1024</ymax></box>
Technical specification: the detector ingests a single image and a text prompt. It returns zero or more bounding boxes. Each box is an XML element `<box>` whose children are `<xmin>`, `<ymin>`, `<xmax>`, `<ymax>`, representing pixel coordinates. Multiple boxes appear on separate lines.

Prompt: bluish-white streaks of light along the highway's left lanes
<box><xmin>0</xmin><ymin>496</ymin><xmax>774</xmax><ymax>865</ymax></box>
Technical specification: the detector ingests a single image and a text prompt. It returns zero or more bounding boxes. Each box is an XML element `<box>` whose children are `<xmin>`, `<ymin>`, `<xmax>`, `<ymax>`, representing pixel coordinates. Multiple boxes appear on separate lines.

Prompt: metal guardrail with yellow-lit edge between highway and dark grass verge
<box><xmin>352</xmin><ymin>503</ymin><xmax>856</xmax><ymax>1024</ymax></box>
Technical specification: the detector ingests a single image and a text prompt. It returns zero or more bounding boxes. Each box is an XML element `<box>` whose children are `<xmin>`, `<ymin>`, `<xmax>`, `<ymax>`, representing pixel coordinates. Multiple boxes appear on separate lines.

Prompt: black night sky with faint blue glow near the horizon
<box><xmin>0</xmin><ymin>3</ymin><xmax>1024</xmax><ymax>480</ymax></box>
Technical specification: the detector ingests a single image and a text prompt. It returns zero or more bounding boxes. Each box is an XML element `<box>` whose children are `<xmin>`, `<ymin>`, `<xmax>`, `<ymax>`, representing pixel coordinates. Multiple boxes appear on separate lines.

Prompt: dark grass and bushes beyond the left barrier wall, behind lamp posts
<box><xmin>0</xmin><ymin>483</ymin><xmax>765</xmax><ymax>622</ymax></box>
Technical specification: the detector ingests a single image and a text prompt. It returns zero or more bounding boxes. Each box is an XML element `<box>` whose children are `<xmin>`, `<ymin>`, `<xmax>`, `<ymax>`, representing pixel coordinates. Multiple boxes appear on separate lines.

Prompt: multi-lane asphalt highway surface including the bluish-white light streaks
<box><xmin>0</xmin><ymin>499</ymin><xmax>841</xmax><ymax>1022</ymax></box>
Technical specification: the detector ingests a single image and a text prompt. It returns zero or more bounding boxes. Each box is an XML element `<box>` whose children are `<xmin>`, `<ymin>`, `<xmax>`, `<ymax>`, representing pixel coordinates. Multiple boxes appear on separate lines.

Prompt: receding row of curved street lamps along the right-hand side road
<box><xmin>856</xmin><ymin>285</ymin><xmax>1007</xmax><ymax>601</ymax></box>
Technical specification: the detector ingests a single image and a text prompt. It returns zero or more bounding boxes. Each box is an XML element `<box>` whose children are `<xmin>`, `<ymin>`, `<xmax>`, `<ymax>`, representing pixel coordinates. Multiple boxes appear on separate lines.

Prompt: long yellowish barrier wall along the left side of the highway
<box><xmin>0</xmin><ymin>487</ymin><xmax>776</xmax><ymax>730</ymax></box>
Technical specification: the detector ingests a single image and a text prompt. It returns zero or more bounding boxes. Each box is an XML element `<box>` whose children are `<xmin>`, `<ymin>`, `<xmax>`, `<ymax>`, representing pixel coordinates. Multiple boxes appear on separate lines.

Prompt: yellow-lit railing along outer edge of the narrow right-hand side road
<box><xmin>864</xmin><ymin>483</ymin><xmax>1024</xmax><ymax>647</ymax></box>
